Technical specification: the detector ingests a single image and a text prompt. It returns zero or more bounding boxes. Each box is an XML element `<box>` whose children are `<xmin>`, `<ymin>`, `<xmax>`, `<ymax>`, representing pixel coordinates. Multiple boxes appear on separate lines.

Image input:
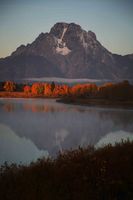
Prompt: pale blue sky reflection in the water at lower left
<box><xmin>0</xmin><ymin>124</ymin><xmax>48</xmax><ymax>164</ymax></box>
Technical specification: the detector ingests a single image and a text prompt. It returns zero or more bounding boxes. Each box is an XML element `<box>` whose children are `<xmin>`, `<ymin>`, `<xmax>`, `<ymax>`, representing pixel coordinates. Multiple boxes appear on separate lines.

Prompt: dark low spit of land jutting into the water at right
<box><xmin>57</xmin><ymin>97</ymin><xmax>133</xmax><ymax>109</ymax></box>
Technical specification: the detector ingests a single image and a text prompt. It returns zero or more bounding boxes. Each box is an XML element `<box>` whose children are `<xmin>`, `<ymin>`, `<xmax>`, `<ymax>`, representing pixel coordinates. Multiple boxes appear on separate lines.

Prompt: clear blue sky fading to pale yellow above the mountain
<box><xmin>0</xmin><ymin>0</ymin><xmax>133</xmax><ymax>57</ymax></box>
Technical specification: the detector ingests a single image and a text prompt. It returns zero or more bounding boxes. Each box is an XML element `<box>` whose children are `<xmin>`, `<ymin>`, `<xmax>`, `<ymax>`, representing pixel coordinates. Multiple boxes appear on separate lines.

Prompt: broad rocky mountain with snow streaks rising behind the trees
<box><xmin>0</xmin><ymin>23</ymin><xmax>133</xmax><ymax>80</ymax></box>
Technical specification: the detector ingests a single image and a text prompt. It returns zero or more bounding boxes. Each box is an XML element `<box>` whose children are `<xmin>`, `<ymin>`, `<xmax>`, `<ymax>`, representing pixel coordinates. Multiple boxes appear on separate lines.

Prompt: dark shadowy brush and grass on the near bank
<box><xmin>0</xmin><ymin>141</ymin><xmax>133</xmax><ymax>200</ymax></box>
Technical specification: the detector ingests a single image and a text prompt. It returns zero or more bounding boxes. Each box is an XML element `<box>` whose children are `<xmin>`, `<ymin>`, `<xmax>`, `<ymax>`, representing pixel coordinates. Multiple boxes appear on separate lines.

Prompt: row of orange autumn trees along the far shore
<box><xmin>1</xmin><ymin>80</ymin><xmax>133</xmax><ymax>100</ymax></box>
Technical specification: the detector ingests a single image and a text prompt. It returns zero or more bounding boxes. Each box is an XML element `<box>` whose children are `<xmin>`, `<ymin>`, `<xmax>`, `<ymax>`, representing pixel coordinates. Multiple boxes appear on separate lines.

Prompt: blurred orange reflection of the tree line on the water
<box><xmin>1</xmin><ymin>101</ymin><xmax>133</xmax><ymax>128</ymax></box>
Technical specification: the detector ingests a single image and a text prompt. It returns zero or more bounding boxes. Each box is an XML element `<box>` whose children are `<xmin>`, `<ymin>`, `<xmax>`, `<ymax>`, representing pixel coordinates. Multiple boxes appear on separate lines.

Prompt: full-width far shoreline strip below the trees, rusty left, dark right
<box><xmin>0</xmin><ymin>92</ymin><xmax>133</xmax><ymax>109</ymax></box>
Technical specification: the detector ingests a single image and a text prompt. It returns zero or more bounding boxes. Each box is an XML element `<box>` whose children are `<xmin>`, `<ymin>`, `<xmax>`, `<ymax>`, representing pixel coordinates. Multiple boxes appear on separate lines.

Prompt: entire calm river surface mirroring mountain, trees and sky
<box><xmin>0</xmin><ymin>99</ymin><xmax>133</xmax><ymax>164</ymax></box>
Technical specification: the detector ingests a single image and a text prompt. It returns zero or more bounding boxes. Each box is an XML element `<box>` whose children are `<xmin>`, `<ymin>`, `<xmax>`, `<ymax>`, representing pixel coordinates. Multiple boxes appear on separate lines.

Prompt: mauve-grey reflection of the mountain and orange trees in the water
<box><xmin>0</xmin><ymin>99</ymin><xmax>133</xmax><ymax>164</ymax></box>
